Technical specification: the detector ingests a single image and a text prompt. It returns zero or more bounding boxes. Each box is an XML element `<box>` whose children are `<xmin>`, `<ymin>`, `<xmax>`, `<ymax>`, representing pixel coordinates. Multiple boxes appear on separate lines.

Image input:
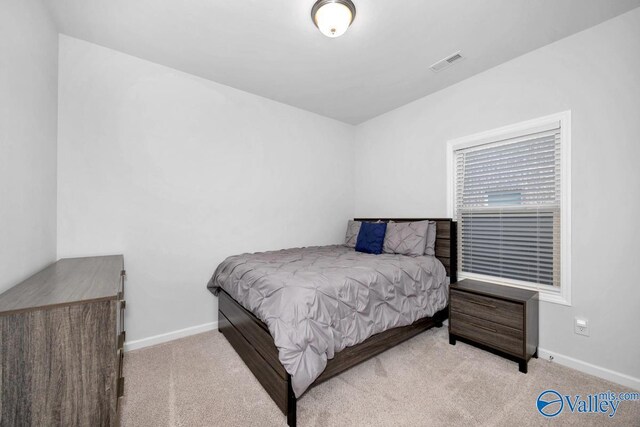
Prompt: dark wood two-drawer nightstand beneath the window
<box><xmin>449</xmin><ymin>279</ymin><xmax>538</xmax><ymax>374</ymax></box>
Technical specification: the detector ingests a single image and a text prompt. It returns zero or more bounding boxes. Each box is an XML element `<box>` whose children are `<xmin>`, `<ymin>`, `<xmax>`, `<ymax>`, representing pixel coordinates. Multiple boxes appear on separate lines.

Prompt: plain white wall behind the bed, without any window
<box><xmin>58</xmin><ymin>36</ymin><xmax>354</xmax><ymax>341</ymax></box>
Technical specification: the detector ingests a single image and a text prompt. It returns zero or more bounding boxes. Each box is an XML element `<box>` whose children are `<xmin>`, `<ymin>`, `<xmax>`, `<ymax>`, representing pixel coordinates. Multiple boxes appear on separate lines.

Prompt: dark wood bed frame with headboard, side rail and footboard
<box><xmin>212</xmin><ymin>218</ymin><xmax>457</xmax><ymax>427</ymax></box>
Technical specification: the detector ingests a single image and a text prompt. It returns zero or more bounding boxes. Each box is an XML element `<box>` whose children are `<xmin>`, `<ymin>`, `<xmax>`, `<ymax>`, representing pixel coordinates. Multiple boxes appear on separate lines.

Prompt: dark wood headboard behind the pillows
<box><xmin>354</xmin><ymin>218</ymin><xmax>458</xmax><ymax>283</ymax></box>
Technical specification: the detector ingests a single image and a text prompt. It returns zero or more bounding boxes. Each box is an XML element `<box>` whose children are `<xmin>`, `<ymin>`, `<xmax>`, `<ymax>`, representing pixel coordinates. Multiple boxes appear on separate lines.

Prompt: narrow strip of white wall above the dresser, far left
<box><xmin>0</xmin><ymin>0</ymin><xmax>58</xmax><ymax>293</ymax></box>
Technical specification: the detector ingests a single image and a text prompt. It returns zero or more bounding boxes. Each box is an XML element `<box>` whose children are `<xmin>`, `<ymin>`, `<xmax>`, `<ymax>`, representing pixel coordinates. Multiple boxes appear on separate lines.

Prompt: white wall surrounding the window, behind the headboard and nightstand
<box><xmin>355</xmin><ymin>9</ymin><xmax>640</xmax><ymax>384</ymax></box>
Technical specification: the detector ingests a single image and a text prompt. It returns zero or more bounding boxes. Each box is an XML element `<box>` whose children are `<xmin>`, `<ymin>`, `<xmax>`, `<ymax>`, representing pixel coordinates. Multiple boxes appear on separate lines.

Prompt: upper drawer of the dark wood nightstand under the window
<box><xmin>451</xmin><ymin>289</ymin><xmax>524</xmax><ymax>331</ymax></box>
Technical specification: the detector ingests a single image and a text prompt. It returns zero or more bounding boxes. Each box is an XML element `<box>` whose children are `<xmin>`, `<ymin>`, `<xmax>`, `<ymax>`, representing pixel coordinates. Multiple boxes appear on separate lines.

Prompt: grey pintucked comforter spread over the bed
<box><xmin>208</xmin><ymin>245</ymin><xmax>447</xmax><ymax>397</ymax></box>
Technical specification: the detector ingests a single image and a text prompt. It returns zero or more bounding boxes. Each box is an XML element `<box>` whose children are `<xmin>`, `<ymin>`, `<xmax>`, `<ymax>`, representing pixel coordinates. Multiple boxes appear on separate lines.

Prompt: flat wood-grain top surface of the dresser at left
<box><xmin>0</xmin><ymin>255</ymin><xmax>124</xmax><ymax>316</ymax></box>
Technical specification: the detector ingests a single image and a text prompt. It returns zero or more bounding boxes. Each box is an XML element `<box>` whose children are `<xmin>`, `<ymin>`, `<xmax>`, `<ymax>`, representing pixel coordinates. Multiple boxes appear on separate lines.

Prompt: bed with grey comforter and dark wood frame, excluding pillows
<box><xmin>208</xmin><ymin>218</ymin><xmax>457</xmax><ymax>426</ymax></box>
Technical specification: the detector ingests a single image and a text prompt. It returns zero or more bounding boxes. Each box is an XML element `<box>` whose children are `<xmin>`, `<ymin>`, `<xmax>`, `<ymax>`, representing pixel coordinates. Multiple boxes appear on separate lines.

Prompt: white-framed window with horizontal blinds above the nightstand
<box><xmin>448</xmin><ymin>112</ymin><xmax>571</xmax><ymax>305</ymax></box>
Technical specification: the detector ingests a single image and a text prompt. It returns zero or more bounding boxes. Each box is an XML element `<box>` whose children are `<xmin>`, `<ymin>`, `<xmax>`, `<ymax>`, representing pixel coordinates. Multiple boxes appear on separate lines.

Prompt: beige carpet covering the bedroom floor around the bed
<box><xmin>121</xmin><ymin>328</ymin><xmax>640</xmax><ymax>427</ymax></box>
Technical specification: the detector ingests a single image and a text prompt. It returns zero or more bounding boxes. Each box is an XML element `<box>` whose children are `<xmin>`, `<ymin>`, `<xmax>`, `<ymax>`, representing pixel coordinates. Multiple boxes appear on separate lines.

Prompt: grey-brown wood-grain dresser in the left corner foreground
<box><xmin>0</xmin><ymin>255</ymin><xmax>125</xmax><ymax>426</ymax></box>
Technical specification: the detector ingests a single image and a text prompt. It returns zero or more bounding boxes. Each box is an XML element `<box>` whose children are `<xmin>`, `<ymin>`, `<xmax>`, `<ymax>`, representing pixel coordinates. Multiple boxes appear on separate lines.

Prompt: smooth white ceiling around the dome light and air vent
<box><xmin>47</xmin><ymin>0</ymin><xmax>640</xmax><ymax>124</ymax></box>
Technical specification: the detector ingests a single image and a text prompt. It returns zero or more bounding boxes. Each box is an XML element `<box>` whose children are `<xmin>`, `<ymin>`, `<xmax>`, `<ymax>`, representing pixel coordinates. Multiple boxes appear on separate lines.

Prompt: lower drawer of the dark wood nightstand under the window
<box><xmin>449</xmin><ymin>310</ymin><xmax>524</xmax><ymax>357</ymax></box>
